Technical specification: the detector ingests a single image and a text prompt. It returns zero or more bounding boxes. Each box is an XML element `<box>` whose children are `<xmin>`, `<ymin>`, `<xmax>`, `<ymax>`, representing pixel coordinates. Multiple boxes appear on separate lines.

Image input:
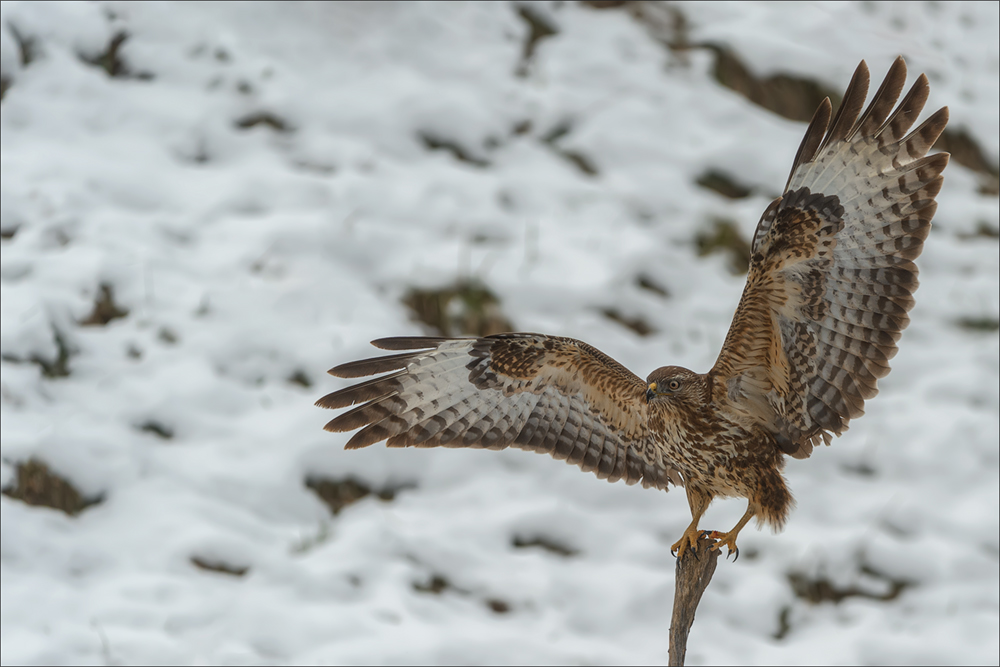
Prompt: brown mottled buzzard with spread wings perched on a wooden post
<box><xmin>317</xmin><ymin>58</ymin><xmax>949</xmax><ymax>557</ymax></box>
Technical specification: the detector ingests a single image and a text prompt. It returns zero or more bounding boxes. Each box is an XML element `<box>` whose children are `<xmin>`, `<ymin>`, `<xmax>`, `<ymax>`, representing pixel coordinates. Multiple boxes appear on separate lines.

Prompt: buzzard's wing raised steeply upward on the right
<box><xmin>712</xmin><ymin>58</ymin><xmax>948</xmax><ymax>458</ymax></box>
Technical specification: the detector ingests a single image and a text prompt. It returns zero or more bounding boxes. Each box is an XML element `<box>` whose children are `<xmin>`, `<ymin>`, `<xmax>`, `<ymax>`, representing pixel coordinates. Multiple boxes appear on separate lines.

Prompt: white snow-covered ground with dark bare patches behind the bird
<box><xmin>0</xmin><ymin>2</ymin><xmax>1000</xmax><ymax>664</ymax></box>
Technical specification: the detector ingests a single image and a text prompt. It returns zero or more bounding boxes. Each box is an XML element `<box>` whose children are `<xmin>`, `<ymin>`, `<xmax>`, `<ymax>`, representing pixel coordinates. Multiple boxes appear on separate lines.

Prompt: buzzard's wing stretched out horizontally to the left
<box><xmin>316</xmin><ymin>334</ymin><xmax>681</xmax><ymax>489</ymax></box>
